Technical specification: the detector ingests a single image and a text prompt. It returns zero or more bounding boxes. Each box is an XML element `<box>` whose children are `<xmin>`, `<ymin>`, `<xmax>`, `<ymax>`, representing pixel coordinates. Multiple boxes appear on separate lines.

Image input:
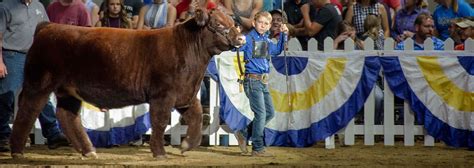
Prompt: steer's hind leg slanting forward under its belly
<box><xmin>56</xmin><ymin>95</ymin><xmax>97</xmax><ymax>158</ymax></box>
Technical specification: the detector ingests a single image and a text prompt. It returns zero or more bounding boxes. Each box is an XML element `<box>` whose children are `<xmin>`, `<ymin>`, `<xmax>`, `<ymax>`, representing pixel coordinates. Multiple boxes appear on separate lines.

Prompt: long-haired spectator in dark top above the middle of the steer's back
<box><xmin>95</xmin><ymin>0</ymin><xmax>132</xmax><ymax>29</ymax></box>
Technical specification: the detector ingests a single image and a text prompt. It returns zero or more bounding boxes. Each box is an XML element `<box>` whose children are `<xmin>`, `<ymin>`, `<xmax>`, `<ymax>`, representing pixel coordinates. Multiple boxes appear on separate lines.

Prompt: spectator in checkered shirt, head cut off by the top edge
<box><xmin>344</xmin><ymin>0</ymin><xmax>390</xmax><ymax>37</ymax></box>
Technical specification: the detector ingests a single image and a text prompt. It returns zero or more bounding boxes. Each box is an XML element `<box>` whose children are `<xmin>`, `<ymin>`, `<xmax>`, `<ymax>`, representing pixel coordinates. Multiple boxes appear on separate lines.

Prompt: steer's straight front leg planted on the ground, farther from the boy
<box><xmin>150</xmin><ymin>98</ymin><xmax>172</xmax><ymax>159</ymax></box>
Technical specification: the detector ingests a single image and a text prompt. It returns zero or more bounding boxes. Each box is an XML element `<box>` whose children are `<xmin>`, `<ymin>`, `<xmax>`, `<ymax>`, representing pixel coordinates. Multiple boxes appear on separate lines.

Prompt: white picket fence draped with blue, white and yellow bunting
<box><xmin>33</xmin><ymin>38</ymin><xmax>474</xmax><ymax>149</ymax></box>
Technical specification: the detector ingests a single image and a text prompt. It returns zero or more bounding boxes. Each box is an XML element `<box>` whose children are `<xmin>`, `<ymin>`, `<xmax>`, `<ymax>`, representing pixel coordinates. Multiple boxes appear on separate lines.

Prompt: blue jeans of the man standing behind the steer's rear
<box><xmin>0</xmin><ymin>51</ymin><xmax>60</xmax><ymax>141</ymax></box>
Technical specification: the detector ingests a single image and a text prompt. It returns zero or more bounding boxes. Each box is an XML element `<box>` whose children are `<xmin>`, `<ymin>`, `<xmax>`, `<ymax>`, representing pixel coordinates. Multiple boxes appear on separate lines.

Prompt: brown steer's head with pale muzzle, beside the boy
<box><xmin>194</xmin><ymin>7</ymin><xmax>245</xmax><ymax>51</ymax></box>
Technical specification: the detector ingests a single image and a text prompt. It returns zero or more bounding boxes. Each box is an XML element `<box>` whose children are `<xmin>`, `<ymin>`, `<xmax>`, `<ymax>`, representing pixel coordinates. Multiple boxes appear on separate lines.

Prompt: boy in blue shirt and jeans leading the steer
<box><xmin>235</xmin><ymin>11</ymin><xmax>288</xmax><ymax>157</ymax></box>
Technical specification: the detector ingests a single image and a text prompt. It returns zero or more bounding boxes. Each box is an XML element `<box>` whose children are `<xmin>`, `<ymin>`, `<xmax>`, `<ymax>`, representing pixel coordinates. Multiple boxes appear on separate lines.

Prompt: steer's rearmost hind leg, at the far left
<box><xmin>10</xmin><ymin>88</ymin><xmax>51</xmax><ymax>158</ymax></box>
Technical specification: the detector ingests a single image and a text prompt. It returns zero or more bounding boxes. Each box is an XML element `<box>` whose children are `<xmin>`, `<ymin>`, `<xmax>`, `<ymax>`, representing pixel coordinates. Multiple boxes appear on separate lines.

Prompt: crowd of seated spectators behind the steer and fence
<box><xmin>32</xmin><ymin>0</ymin><xmax>474</xmax><ymax>50</ymax></box>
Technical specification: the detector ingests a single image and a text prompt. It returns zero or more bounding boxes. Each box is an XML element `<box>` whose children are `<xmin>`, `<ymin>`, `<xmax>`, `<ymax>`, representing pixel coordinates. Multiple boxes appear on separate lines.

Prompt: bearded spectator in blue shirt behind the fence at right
<box><xmin>395</xmin><ymin>13</ymin><xmax>444</xmax><ymax>50</ymax></box>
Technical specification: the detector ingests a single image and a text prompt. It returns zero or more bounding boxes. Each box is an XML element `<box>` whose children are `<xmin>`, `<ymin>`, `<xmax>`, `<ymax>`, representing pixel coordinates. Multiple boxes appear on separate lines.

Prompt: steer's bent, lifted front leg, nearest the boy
<box><xmin>178</xmin><ymin>99</ymin><xmax>202</xmax><ymax>153</ymax></box>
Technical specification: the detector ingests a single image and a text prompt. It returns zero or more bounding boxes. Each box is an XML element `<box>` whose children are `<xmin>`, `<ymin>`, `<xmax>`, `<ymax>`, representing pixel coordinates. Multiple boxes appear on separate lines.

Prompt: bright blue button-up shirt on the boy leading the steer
<box><xmin>240</xmin><ymin>29</ymin><xmax>287</xmax><ymax>74</ymax></box>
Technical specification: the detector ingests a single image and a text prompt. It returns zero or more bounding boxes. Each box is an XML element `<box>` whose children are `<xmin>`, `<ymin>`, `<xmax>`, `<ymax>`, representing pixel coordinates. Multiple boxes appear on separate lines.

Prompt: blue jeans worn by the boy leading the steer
<box><xmin>242</xmin><ymin>78</ymin><xmax>275</xmax><ymax>151</ymax></box>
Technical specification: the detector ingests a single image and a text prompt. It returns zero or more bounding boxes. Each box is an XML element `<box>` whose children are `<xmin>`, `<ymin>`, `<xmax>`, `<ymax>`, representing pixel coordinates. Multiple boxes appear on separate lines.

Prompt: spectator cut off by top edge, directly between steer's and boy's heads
<box><xmin>224</xmin><ymin>0</ymin><xmax>263</xmax><ymax>33</ymax></box>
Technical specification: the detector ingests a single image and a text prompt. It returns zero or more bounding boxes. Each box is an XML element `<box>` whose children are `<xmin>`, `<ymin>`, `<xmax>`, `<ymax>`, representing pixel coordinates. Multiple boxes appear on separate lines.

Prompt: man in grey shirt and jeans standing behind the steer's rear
<box><xmin>0</xmin><ymin>0</ymin><xmax>69</xmax><ymax>152</ymax></box>
